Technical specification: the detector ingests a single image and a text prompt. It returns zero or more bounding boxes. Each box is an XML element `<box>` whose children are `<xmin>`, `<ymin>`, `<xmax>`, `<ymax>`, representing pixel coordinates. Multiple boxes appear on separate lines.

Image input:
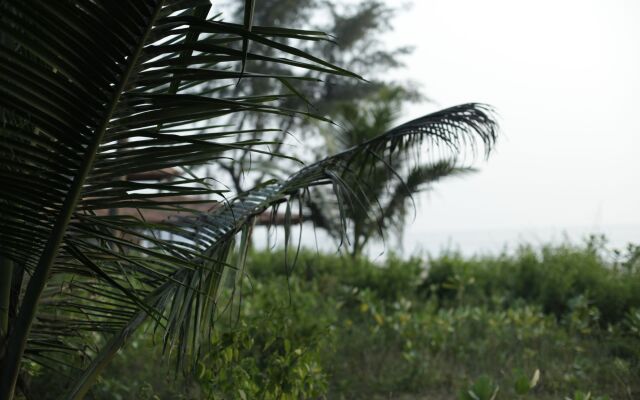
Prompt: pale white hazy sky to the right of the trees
<box><xmin>376</xmin><ymin>0</ymin><xmax>640</xmax><ymax>250</ymax></box>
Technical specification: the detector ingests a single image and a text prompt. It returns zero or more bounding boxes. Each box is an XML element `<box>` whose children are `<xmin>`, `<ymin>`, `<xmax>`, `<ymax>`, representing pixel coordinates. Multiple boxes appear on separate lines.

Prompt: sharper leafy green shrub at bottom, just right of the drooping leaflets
<box><xmin>197</xmin><ymin>304</ymin><xmax>327</xmax><ymax>399</ymax></box>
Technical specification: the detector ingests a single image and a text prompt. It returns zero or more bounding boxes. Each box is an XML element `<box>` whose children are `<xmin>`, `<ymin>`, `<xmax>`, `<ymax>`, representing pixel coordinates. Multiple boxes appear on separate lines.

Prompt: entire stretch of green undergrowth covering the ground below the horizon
<box><xmin>34</xmin><ymin>239</ymin><xmax>640</xmax><ymax>400</ymax></box>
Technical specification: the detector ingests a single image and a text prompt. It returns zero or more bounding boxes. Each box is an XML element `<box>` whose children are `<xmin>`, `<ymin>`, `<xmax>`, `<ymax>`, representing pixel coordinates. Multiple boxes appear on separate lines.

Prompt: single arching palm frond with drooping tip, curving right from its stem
<box><xmin>62</xmin><ymin>104</ymin><xmax>496</xmax><ymax>398</ymax></box>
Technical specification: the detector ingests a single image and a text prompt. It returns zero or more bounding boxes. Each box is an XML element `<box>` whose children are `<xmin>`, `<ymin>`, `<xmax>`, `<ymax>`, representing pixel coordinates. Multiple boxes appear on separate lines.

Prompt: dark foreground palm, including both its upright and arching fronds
<box><xmin>0</xmin><ymin>0</ymin><xmax>495</xmax><ymax>399</ymax></box>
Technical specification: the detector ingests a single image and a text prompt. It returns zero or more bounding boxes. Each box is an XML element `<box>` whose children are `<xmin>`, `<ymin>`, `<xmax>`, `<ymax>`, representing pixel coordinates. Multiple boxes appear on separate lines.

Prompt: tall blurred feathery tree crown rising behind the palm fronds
<box><xmin>218</xmin><ymin>0</ymin><xmax>419</xmax><ymax>191</ymax></box>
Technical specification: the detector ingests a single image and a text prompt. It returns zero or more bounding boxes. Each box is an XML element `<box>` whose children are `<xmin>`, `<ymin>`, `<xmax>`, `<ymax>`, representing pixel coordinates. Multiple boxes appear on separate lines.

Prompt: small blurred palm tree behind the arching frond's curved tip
<box><xmin>307</xmin><ymin>86</ymin><xmax>472</xmax><ymax>257</ymax></box>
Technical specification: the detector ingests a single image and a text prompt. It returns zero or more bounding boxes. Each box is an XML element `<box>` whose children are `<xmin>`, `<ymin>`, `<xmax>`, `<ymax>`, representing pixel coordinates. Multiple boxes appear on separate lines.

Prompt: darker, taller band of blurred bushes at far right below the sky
<box><xmin>422</xmin><ymin>234</ymin><xmax>640</xmax><ymax>326</ymax></box>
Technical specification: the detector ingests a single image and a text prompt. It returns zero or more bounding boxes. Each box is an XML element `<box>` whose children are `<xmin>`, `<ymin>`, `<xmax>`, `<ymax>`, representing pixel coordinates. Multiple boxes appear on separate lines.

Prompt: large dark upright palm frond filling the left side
<box><xmin>0</xmin><ymin>0</ymin><xmax>355</xmax><ymax>398</ymax></box>
